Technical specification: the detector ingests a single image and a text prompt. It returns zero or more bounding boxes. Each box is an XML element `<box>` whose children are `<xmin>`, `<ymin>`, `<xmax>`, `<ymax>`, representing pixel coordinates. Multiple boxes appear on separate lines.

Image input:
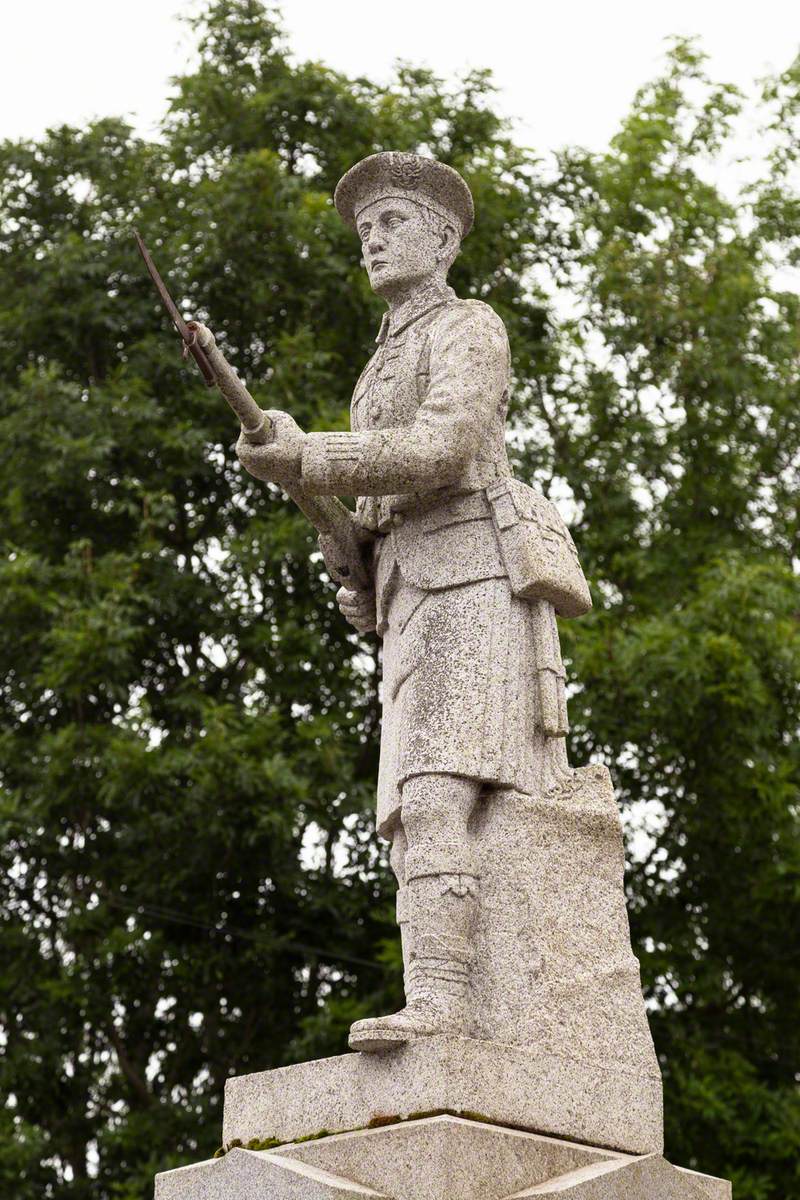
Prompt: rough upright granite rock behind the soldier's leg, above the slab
<box><xmin>464</xmin><ymin>766</ymin><xmax>661</xmax><ymax>1080</ymax></box>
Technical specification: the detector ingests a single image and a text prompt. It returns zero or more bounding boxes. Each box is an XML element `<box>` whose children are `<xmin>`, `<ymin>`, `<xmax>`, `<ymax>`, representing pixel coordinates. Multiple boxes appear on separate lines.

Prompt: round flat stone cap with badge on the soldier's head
<box><xmin>333</xmin><ymin>150</ymin><xmax>475</xmax><ymax>238</ymax></box>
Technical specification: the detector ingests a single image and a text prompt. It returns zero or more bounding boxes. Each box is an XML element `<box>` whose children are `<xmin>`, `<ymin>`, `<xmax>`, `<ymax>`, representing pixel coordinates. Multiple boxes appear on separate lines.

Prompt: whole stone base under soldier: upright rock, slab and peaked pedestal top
<box><xmin>156</xmin><ymin>767</ymin><xmax>730</xmax><ymax>1200</ymax></box>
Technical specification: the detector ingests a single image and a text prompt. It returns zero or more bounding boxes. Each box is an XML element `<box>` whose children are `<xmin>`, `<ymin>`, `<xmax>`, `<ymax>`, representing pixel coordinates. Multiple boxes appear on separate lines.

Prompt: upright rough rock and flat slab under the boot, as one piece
<box><xmin>219</xmin><ymin>767</ymin><xmax>663</xmax><ymax>1154</ymax></box>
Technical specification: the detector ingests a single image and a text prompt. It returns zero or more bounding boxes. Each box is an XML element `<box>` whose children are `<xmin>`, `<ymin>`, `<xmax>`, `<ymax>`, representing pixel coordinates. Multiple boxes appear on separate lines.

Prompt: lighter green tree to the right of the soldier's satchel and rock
<box><xmin>527</xmin><ymin>41</ymin><xmax>800</xmax><ymax>1200</ymax></box>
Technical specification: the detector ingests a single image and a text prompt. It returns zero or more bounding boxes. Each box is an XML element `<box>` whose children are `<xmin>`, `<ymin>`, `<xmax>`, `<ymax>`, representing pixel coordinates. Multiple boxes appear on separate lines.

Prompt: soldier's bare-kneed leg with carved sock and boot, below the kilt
<box><xmin>350</xmin><ymin>774</ymin><xmax>481</xmax><ymax>1051</ymax></box>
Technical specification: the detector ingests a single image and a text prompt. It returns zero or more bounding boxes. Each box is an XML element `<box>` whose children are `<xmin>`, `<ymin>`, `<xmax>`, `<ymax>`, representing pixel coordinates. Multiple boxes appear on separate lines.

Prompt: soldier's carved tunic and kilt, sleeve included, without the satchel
<box><xmin>302</xmin><ymin>288</ymin><xmax>556</xmax><ymax>834</ymax></box>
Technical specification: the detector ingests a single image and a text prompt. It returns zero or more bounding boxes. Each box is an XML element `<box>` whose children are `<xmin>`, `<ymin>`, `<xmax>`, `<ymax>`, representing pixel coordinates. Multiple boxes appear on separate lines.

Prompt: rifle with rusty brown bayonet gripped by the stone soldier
<box><xmin>133</xmin><ymin>229</ymin><xmax>372</xmax><ymax>592</ymax></box>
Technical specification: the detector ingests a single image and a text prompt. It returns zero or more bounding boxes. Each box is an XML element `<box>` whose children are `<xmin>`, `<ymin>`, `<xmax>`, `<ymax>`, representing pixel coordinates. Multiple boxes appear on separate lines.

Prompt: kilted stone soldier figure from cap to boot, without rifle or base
<box><xmin>198</xmin><ymin>151</ymin><xmax>590</xmax><ymax>1051</ymax></box>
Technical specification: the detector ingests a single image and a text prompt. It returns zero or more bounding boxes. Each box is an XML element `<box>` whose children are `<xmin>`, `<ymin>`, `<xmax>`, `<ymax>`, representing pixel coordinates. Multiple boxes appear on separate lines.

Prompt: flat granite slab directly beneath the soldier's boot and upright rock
<box><xmin>223</xmin><ymin>1037</ymin><xmax>662</xmax><ymax>1154</ymax></box>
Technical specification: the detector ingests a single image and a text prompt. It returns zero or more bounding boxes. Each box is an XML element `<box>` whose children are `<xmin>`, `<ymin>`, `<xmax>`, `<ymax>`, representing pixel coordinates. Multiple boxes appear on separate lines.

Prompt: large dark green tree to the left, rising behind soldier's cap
<box><xmin>0</xmin><ymin>0</ymin><xmax>551</xmax><ymax>1200</ymax></box>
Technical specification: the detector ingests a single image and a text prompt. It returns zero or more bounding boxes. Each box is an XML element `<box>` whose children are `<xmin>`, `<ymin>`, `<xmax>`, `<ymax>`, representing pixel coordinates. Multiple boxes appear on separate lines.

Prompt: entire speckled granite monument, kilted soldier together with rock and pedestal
<box><xmin>156</xmin><ymin>152</ymin><xmax>730</xmax><ymax>1200</ymax></box>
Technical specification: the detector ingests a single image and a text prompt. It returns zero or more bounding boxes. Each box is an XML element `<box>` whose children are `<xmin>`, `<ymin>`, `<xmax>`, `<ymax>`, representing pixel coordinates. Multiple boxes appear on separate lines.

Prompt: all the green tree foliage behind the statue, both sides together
<box><xmin>0</xmin><ymin>0</ymin><xmax>800</xmax><ymax>1200</ymax></box>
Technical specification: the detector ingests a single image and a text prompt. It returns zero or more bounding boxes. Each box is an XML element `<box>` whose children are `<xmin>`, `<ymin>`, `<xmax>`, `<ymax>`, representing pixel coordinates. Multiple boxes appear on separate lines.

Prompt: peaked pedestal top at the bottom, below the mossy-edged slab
<box><xmin>156</xmin><ymin>1116</ymin><xmax>730</xmax><ymax>1200</ymax></box>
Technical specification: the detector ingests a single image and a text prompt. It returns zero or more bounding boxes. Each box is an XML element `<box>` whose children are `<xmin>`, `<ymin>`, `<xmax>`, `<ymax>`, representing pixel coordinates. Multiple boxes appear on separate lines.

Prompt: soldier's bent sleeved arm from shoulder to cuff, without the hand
<box><xmin>301</xmin><ymin>305</ymin><xmax>509</xmax><ymax>496</ymax></box>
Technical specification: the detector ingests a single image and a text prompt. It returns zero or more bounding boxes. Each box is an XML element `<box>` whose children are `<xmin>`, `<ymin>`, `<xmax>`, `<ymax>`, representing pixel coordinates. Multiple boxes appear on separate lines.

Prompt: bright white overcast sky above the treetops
<box><xmin>0</xmin><ymin>0</ymin><xmax>800</xmax><ymax>150</ymax></box>
